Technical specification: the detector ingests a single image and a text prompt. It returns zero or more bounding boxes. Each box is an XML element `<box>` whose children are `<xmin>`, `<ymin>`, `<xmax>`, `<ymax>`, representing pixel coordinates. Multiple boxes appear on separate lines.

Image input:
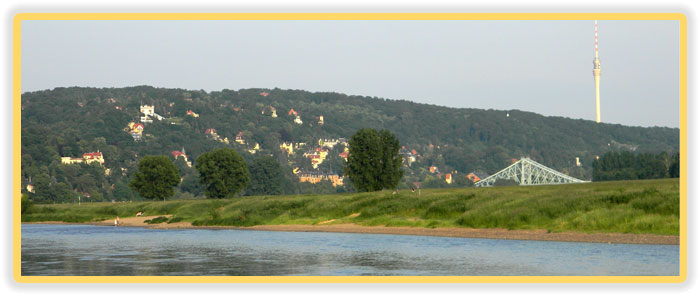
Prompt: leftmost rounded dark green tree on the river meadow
<box><xmin>129</xmin><ymin>156</ymin><xmax>180</xmax><ymax>201</ymax></box>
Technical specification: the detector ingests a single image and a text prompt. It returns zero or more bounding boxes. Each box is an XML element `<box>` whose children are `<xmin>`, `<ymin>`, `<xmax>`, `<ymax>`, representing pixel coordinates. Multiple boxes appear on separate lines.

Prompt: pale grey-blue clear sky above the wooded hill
<box><xmin>22</xmin><ymin>20</ymin><xmax>680</xmax><ymax>128</ymax></box>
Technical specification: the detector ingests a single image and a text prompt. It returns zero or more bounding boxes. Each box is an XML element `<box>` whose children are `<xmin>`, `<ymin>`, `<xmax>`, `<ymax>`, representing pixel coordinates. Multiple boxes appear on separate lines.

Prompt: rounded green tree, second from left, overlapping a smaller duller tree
<box><xmin>195</xmin><ymin>148</ymin><xmax>250</xmax><ymax>199</ymax></box>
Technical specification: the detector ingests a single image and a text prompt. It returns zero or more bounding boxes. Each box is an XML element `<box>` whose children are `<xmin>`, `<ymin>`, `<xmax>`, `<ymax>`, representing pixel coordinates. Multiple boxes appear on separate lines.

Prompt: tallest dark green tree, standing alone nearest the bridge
<box><xmin>344</xmin><ymin>128</ymin><xmax>403</xmax><ymax>192</ymax></box>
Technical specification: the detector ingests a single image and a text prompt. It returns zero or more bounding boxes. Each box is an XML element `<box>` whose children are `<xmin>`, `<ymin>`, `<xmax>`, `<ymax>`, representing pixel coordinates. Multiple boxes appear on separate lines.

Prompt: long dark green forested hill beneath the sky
<box><xmin>22</xmin><ymin>86</ymin><xmax>680</xmax><ymax>201</ymax></box>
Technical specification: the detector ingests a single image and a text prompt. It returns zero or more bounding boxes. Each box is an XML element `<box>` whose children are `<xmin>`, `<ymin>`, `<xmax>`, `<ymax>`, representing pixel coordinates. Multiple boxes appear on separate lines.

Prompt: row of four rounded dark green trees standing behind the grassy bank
<box><xmin>129</xmin><ymin>128</ymin><xmax>403</xmax><ymax>201</ymax></box>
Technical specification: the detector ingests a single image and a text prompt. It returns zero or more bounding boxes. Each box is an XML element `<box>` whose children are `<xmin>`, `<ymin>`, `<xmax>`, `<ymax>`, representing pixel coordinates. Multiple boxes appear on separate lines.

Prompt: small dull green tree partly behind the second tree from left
<box><xmin>246</xmin><ymin>157</ymin><xmax>282</xmax><ymax>195</ymax></box>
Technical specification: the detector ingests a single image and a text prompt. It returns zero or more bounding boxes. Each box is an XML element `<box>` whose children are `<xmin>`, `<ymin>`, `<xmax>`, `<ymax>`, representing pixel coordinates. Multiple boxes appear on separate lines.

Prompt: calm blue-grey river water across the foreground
<box><xmin>22</xmin><ymin>224</ymin><xmax>679</xmax><ymax>276</ymax></box>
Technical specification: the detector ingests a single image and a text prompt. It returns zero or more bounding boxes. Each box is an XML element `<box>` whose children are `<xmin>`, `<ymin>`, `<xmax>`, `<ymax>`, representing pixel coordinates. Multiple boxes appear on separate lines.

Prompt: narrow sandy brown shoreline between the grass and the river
<box><xmin>22</xmin><ymin>215</ymin><xmax>680</xmax><ymax>245</ymax></box>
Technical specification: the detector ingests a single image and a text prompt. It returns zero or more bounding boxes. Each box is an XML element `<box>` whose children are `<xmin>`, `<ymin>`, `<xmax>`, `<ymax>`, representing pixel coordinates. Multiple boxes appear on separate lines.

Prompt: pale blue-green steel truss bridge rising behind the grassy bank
<box><xmin>474</xmin><ymin>158</ymin><xmax>587</xmax><ymax>187</ymax></box>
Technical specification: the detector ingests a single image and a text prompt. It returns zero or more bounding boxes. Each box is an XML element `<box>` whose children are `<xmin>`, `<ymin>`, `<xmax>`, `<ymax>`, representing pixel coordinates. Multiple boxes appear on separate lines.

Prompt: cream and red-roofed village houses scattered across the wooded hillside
<box><xmin>49</xmin><ymin>92</ymin><xmax>470</xmax><ymax>199</ymax></box>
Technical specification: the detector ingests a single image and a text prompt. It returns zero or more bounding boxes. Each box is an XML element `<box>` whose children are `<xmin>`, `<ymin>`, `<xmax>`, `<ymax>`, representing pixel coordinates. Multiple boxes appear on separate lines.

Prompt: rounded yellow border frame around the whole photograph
<box><xmin>12</xmin><ymin>13</ymin><xmax>688</xmax><ymax>283</ymax></box>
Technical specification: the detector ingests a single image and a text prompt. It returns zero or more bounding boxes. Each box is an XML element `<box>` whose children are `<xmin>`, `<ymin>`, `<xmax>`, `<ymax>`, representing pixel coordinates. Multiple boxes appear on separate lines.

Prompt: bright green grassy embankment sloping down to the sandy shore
<box><xmin>22</xmin><ymin>179</ymin><xmax>680</xmax><ymax>235</ymax></box>
